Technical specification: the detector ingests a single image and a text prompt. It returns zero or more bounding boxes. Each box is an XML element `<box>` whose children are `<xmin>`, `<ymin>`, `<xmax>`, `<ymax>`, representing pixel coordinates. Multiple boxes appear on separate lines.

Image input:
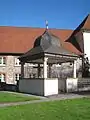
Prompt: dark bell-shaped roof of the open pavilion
<box><xmin>19</xmin><ymin>29</ymin><xmax>76</xmax><ymax>61</ymax></box>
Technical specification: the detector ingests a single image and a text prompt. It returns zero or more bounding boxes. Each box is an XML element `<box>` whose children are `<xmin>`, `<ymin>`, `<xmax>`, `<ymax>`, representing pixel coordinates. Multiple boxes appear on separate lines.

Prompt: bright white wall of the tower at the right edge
<box><xmin>83</xmin><ymin>32</ymin><xmax>90</xmax><ymax>61</ymax></box>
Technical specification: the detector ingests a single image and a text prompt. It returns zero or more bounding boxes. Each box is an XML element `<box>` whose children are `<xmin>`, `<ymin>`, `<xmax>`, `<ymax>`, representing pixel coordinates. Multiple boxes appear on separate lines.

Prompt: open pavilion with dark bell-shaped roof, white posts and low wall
<box><xmin>19</xmin><ymin>29</ymin><xmax>78</xmax><ymax>96</ymax></box>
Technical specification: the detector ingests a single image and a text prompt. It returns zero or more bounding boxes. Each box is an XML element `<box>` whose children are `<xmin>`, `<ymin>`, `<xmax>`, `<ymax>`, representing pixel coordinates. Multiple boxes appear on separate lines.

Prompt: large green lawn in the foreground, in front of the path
<box><xmin>0</xmin><ymin>98</ymin><xmax>90</xmax><ymax>120</ymax></box>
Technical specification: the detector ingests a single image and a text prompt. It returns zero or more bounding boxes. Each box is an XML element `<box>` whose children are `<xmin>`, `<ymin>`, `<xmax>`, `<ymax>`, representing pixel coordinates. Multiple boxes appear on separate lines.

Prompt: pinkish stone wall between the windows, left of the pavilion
<box><xmin>0</xmin><ymin>56</ymin><xmax>21</xmax><ymax>84</ymax></box>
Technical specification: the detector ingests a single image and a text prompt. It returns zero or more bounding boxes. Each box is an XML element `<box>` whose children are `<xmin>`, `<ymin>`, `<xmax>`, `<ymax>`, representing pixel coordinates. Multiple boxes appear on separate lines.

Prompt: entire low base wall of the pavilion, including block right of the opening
<box><xmin>19</xmin><ymin>78</ymin><xmax>78</xmax><ymax>96</ymax></box>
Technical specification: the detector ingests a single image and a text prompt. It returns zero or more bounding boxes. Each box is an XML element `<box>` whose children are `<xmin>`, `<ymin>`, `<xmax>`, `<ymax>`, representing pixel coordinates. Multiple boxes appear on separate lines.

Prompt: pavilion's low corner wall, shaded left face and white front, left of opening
<box><xmin>19</xmin><ymin>78</ymin><xmax>58</xmax><ymax>96</ymax></box>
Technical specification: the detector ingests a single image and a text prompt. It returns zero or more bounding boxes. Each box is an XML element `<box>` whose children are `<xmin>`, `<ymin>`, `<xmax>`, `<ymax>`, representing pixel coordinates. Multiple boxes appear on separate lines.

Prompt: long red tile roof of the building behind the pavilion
<box><xmin>0</xmin><ymin>27</ymin><xmax>80</xmax><ymax>54</ymax></box>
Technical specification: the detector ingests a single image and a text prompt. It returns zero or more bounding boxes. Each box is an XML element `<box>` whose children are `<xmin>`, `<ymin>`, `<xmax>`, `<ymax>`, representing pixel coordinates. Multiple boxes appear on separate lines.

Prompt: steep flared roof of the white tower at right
<box><xmin>65</xmin><ymin>14</ymin><xmax>90</xmax><ymax>53</ymax></box>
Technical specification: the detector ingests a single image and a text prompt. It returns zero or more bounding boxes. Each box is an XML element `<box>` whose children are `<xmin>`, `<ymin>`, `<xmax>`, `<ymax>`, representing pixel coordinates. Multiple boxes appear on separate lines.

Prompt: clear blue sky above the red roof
<box><xmin>0</xmin><ymin>0</ymin><xmax>90</xmax><ymax>29</ymax></box>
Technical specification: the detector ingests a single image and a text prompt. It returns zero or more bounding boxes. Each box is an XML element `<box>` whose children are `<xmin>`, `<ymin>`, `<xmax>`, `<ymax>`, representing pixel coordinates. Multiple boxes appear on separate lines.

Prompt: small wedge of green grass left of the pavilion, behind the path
<box><xmin>0</xmin><ymin>92</ymin><xmax>39</xmax><ymax>103</ymax></box>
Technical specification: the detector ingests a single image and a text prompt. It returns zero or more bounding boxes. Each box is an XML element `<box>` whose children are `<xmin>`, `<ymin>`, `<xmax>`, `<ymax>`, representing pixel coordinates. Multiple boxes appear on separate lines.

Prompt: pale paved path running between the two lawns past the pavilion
<box><xmin>0</xmin><ymin>93</ymin><xmax>90</xmax><ymax>107</ymax></box>
